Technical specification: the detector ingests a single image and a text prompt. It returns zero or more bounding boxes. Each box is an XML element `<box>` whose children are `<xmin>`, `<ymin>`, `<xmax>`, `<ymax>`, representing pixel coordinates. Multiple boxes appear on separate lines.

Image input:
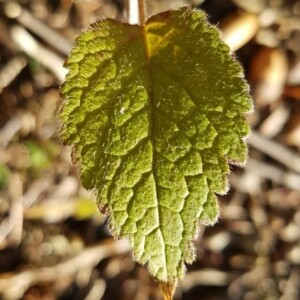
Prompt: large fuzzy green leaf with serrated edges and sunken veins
<box><xmin>60</xmin><ymin>8</ymin><xmax>252</xmax><ymax>283</ymax></box>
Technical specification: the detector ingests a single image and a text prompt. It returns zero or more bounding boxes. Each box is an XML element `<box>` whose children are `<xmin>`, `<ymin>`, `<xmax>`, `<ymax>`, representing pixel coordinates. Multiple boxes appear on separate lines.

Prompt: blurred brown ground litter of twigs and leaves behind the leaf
<box><xmin>0</xmin><ymin>0</ymin><xmax>300</xmax><ymax>300</ymax></box>
